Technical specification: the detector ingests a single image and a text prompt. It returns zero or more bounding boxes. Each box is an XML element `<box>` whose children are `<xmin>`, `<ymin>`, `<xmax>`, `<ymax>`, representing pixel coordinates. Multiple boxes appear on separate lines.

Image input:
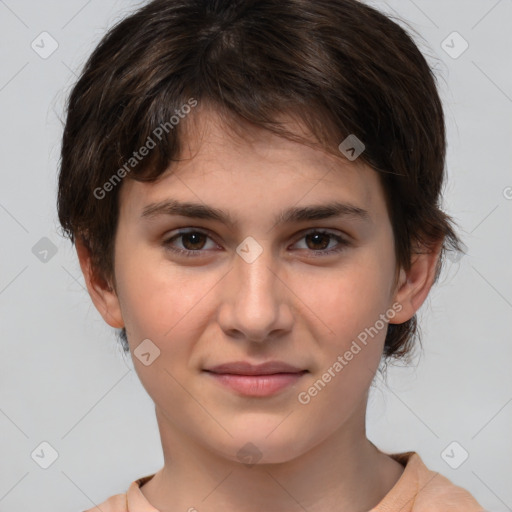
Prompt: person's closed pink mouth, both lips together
<box><xmin>204</xmin><ymin>361</ymin><xmax>309</xmax><ymax>397</ymax></box>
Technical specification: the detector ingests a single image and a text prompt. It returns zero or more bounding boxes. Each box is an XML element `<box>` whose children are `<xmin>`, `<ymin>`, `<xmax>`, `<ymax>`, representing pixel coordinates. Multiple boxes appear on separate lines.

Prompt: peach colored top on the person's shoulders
<box><xmin>85</xmin><ymin>452</ymin><xmax>485</xmax><ymax>512</ymax></box>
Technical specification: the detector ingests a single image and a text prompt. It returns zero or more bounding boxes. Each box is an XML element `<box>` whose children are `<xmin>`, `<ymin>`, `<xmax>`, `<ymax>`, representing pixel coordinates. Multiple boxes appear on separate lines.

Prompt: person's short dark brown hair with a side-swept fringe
<box><xmin>58</xmin><ymin>0</ymin><xmax>461</xmax><ymax>359</ymax></box>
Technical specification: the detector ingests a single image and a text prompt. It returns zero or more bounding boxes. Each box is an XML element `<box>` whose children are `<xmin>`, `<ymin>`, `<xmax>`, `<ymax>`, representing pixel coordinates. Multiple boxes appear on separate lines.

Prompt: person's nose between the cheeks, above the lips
<box><xmin>218</xmin><ymin>245</ymin><xmax>293</xmax><ymax>343</ymax></box>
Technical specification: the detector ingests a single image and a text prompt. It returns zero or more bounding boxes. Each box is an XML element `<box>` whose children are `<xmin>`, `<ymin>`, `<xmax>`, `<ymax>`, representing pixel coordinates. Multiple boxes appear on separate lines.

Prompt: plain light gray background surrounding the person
<box><xmin>0</xmin><ymin>0</ymin><xmax>512</xmax><ymax>512</ymax></box>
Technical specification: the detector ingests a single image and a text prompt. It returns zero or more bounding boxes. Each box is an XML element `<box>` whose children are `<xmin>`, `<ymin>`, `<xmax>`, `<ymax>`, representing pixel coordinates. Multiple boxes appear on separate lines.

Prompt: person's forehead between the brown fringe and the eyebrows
<box><xmin>120</xmin><ymin>108</ymin><xmax>386</xmax><ymax>226</ymax></box>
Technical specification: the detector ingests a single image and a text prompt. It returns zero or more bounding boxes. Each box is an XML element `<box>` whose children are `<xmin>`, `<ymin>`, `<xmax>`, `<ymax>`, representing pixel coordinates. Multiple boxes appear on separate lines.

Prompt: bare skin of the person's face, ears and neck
<box><xmin>77</xmin><ymin>108</ymin><xmax>440</xmax><ymax>512</ymax></box>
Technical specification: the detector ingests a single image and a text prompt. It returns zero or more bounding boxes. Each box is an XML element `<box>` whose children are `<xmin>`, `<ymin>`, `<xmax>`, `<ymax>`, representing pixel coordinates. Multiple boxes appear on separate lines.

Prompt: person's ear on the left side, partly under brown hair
<box><xmin>75</xmin><ymin>237</ymin><xmax>124</xmax><ymax>329</ymax></box>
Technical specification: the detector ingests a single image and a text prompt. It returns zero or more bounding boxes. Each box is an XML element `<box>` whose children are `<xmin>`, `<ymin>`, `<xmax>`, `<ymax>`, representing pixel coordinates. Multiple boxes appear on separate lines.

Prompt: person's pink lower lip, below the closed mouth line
<box><xmin>207</xmin><ymin>371</ymin><xmax>307</xmax><ymax>396</ymax></box>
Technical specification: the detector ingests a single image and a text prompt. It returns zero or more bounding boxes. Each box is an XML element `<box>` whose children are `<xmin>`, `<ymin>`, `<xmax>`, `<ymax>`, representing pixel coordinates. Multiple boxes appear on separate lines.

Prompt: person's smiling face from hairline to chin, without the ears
<box><xmin>96</xmin><ymin>110</ymin><xmax>410</xmax><ymax>462</ymax></box>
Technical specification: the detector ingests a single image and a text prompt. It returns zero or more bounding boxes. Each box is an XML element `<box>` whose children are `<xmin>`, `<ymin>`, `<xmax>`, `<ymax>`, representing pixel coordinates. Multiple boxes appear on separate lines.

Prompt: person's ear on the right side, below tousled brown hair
<box><xmin>389</xmin><ymin>240</ymin><xmax>443</xmax><ymax>324</ymax></box>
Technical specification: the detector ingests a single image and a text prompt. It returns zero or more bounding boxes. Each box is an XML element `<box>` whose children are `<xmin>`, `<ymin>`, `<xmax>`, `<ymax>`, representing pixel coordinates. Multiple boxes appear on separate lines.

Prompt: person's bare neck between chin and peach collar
<box><xmin>141</xmin><ymin>404</ymin><xmax>404</xmax><ymax>512</ymax></box>
